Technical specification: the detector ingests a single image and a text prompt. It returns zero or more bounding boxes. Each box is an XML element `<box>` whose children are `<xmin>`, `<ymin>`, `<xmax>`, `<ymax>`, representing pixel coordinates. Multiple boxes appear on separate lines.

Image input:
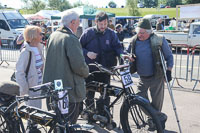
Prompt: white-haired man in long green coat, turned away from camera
<box><xmin>43</xmin><ymin>11</ymin><xmax>89</xmax><ymax>124</ymax></box>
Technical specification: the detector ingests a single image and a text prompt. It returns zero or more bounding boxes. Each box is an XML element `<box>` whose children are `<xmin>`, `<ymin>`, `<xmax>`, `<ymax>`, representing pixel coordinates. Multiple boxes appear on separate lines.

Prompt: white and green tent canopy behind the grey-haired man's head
<box><xmin>51</xmin><ymin>6</ymin><xmax>115</xmax><ymax>20</ymax></box>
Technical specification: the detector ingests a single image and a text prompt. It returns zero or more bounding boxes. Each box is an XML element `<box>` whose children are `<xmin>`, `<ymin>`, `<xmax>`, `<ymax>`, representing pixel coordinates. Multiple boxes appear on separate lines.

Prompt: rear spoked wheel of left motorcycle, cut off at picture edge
<box><xmin>0</xmin><ymin>111</ymin><xmax>12</xmax><ymax>133</ymax></box>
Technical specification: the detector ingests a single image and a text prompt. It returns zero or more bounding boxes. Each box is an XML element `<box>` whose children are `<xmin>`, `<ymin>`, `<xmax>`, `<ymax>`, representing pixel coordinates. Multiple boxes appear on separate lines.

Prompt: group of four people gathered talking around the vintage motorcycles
<box><xmin>16</xmin><ymin>11</ymin><xmax>173</xmax><ymax>132</ymax></box>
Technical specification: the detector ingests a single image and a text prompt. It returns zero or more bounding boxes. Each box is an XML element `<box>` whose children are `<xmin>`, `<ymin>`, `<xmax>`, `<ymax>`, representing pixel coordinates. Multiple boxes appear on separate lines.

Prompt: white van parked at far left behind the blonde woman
<box><xmin>0</xmin><ymin>10</ymin><xmax>29</xmax><ymax>45</ymax></box>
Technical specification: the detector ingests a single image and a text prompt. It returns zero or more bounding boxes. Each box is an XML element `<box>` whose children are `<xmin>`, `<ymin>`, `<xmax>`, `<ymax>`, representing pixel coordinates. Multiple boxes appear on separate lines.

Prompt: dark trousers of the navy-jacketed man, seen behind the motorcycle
<box><xmin>85</xmin><ymin>73</ymin><xmax>110</xmax><ymax>107</ymax></box>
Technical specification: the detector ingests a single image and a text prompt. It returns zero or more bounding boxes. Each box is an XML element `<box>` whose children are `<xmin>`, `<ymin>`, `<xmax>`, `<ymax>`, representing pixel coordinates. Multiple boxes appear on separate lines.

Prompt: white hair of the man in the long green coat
<box><xmin>61</xmin><ymin>11</ymin><xmax>79</xmax><ymax>27</ymax></box>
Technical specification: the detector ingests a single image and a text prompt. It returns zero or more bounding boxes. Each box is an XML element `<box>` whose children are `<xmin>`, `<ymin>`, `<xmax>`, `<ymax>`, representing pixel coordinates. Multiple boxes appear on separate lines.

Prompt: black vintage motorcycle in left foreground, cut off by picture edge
<box><xmin>0</xmin><ymin>82</ymin><xmax>93</xmax><ymax>133</ymax></box>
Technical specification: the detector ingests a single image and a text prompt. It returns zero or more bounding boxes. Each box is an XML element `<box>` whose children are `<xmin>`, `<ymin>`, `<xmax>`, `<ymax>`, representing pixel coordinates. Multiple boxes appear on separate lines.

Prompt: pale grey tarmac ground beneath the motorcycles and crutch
<box><xmin>0</xmin><ymin>62</ymin><xmax>200</xmax><ymax>133</ymax></box>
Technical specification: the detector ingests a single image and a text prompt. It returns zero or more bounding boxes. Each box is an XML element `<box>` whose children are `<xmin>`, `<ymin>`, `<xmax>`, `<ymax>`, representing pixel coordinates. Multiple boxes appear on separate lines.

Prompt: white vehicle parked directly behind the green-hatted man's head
<box><xmin>143</xmin><ymin>14</ymin><xmax>169</xmax><ymax>28</ymax></box>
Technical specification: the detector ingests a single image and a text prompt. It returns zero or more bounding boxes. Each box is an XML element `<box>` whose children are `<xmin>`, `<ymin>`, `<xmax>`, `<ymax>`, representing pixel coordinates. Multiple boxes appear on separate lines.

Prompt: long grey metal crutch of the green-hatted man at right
<box><xmin>159</xmin><ymin>49</ymin><xmax>182</xmax><ymax>133</ymax></box>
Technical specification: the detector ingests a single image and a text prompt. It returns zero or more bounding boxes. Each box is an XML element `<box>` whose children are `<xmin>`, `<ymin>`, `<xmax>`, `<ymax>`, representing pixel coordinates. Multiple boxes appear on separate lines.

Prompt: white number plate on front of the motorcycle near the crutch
<box><xmin>120</xmin><ymin>70</ymin><xmax>133</xmax><ymax>88</ymax></box>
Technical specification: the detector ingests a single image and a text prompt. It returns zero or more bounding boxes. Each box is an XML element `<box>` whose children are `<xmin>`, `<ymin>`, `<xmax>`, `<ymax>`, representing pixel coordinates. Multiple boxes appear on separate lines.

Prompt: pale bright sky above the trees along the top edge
<box><xmin>0</xmin><ymin>0</ymin><xmax>126</xmax><ymax>9</ymax></box>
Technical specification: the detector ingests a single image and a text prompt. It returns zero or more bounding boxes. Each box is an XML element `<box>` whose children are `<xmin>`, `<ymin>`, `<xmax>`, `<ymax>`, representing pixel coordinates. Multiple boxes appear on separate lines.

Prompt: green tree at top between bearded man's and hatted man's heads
<box><xmin>126</xmin><ymin>0</ymin><xmax>140</xmax><ymax>16</ymax></box>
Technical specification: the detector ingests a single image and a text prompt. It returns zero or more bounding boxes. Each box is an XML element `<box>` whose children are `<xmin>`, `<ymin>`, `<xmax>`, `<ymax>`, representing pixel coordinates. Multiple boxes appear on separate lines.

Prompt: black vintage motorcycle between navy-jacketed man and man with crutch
<box><xmin>81</xmin><ymin>63</ymin><xmax>163</xmax><ymax>133</ymax></box>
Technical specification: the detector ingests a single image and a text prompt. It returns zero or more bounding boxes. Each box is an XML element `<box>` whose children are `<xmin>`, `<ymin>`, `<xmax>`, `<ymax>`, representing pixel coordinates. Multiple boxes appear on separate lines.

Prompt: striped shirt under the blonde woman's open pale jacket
<box><xmin>31</xmin><ymin>47</ymin><xmax>43</xmax><ymax>85</ymax></box>
